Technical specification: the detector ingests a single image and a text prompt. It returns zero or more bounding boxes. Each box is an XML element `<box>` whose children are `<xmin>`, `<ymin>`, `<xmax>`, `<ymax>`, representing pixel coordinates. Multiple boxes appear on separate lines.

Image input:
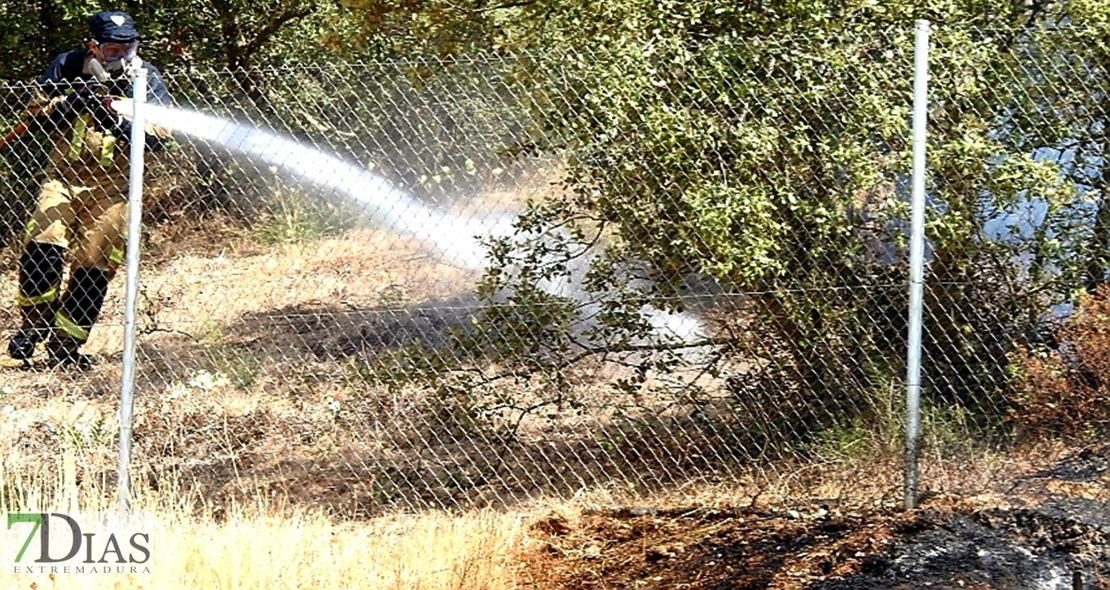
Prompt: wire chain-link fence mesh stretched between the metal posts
<box><xmin>0</xmin><ymin>21</ymin><xmax>1110</xmax><ymax>516</ymax></box>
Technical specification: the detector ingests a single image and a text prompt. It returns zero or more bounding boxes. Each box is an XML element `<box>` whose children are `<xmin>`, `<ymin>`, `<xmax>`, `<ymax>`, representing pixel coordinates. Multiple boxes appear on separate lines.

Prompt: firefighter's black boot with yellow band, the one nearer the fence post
<box><xmin>47</xmin><ymin>267</ymin><xmax>110</xmax><ymax>368</ymax></box>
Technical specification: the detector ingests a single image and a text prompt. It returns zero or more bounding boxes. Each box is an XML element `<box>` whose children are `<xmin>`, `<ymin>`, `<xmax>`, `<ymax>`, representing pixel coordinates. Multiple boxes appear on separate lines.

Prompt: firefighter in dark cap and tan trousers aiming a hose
<box><xmin>8</xmin><ymin>11</ymin><xmax>172</xmax><ymax>368</ymax></box>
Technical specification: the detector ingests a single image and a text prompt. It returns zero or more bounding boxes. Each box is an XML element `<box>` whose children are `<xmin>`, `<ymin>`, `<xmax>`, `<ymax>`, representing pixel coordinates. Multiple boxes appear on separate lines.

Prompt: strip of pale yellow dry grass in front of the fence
<box><xmin>0</xmin><ymin>454</ymin><xmax>525</xmax><ymax>590</ymax></box>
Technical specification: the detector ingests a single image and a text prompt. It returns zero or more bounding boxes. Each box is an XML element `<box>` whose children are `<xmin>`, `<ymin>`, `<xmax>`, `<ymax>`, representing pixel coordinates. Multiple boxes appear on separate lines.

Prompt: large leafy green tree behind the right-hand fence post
<box><xmin>477</xmin><ymin>0</ymin><xmax>1081</xmax><ymax>426</ymax></box>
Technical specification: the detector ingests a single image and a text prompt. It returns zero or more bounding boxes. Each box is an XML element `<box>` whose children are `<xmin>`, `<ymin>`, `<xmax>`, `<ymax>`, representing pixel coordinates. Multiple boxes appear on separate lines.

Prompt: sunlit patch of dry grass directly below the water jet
<box><xmin>88</xmin><ymin>230</ymin><xmax>473</xmax><ymax>353</ymax></box>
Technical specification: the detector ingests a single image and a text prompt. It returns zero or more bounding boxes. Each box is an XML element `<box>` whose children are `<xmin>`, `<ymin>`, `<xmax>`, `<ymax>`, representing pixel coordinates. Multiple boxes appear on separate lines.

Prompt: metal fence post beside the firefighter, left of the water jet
<box><xmin>119</xmin><ymin>68</ymin><xmax>147</xmax><ymax>512</ymax></box>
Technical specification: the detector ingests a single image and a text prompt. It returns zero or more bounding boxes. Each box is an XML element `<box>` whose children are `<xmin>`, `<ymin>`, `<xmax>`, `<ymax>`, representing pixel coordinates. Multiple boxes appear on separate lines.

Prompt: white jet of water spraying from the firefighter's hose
<box><xmin>121</xmin><ymin>101</ymin><xmax>706</xmax><ymax>344</ymax></box>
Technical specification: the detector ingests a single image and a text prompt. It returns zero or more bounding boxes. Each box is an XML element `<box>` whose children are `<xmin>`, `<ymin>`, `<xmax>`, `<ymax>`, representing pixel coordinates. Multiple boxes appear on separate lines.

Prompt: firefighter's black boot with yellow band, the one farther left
<box><xmin>8</xmin><ymin>242</ymin><xmax>65</xmax><ymax>360</ymax></box>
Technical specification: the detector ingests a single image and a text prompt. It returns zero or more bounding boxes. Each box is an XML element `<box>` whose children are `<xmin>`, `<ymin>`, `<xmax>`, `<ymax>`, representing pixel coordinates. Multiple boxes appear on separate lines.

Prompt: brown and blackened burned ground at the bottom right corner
<box><xmin>524</xmin><ymin>446</ymin><xmax>1110</xmax><ymax>590</ymax></box>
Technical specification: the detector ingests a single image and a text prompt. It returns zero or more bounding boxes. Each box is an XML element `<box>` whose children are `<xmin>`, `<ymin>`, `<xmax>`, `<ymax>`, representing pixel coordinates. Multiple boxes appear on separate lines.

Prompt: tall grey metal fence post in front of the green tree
<box><xmin>906</xmin><ymin>20</ymin><xmax>929</xmax><ymax>509</ymax></box>
